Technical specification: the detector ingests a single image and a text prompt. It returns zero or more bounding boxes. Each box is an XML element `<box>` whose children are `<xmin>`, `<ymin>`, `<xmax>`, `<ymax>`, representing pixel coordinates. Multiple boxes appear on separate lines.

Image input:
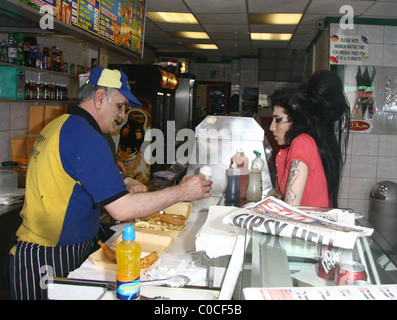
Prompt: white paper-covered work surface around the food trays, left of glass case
<box><xmin>48</xmin><ymin>197</ymin><xmax>229</xmax><ymax>299</ymax></box>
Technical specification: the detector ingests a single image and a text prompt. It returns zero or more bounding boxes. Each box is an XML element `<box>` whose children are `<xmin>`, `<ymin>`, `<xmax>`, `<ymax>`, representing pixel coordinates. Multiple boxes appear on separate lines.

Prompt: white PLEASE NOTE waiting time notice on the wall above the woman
<box><xmin>329</xmin><ymin>34</ymin><xmax>368</xmax><ymax>65</ymax></box>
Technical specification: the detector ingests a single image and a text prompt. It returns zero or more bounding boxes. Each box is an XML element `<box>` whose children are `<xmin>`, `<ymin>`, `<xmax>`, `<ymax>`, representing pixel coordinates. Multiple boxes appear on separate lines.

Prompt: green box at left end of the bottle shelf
<box><xmin>0</xmin><ymin>66</ymin><xmax>25</xmax><ymax>100</ymax></box>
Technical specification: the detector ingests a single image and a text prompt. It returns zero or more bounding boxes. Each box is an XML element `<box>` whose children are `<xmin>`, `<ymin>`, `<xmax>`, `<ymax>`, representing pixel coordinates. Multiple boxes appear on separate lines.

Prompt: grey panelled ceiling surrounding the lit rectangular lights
<box><xmin>145</xmin><ymin>0</ymin><xmax>397</xmax><ymax>57</ymax></box>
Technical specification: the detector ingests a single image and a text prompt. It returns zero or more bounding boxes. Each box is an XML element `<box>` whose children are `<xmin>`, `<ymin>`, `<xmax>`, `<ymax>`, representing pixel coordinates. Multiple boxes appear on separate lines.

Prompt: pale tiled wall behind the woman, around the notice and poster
<box><xmin>330</xmin><ymin>24</ymin><xmax>397</xmax><ymax>216</ymax></box>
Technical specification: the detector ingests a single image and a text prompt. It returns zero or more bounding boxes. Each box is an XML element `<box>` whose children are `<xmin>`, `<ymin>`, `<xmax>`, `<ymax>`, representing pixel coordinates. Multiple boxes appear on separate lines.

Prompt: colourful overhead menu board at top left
<box><xmin>18</xmin><ymin>0</ymin><xmax>146</xmax><ymax>57</ymax></box>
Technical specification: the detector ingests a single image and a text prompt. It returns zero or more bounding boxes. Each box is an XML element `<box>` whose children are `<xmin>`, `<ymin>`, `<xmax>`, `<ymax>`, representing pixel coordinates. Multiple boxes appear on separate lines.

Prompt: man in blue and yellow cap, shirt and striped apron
<box><xmin>9</xmin><ymin>67</ymin><xmax>212</xmax><ymax>299</ymax></box>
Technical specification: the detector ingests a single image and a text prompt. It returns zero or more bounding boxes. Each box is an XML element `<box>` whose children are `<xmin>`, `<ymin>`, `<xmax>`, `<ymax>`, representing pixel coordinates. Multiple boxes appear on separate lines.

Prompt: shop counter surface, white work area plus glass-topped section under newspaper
<box><xmin>44</xmin><ymin>197</ymin><xmax>397</xmax><ymax>300</ymax></box>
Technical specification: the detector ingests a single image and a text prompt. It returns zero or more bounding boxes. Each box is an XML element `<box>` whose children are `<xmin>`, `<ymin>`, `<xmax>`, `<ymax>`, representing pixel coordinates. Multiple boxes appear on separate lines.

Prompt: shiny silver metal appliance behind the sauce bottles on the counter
<box><xmin>187</xmin><ymin>115</ymin><xmax>273</xmax><ymax>197</ymax></box>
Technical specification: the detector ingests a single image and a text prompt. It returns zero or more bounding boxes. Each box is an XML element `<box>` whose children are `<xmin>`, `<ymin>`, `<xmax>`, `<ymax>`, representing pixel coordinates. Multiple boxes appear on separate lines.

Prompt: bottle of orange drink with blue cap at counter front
<box><xmin>116</xmin><ymin>225</ymin><xmax>142</xmax><ymax>300</ymax></box>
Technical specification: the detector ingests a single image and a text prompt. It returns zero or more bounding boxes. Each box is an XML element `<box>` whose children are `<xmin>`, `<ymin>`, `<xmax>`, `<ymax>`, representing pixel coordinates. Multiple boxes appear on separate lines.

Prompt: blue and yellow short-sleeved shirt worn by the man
<box><xmin>17</xmin><ymin>105</ymin><xmax>127</xmax><ymax>246</ymax></box>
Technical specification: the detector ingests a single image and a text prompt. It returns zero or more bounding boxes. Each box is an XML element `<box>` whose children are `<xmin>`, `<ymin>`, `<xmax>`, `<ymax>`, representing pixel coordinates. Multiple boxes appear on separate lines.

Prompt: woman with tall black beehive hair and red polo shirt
<box><xmin>269</xmin><ymin>70</ymin><xmax>350</xmax><ymax>207</ymax></box>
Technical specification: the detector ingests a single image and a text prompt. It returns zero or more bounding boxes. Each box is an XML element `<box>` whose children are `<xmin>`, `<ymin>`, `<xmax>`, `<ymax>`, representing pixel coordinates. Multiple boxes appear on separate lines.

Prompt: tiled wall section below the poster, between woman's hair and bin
<box><xmin>339</xmin><ymin>133</ymin><xmax>397</xmax><ymax>216</ymax></box>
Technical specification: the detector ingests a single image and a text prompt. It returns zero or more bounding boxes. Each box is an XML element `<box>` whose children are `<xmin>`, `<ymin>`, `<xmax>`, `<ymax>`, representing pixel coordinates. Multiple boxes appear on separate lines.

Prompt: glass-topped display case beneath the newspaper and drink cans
<box><xmin>234</xmin><ymin>213</ymin><xmax>397</xmax><ymax>299</ymax></box>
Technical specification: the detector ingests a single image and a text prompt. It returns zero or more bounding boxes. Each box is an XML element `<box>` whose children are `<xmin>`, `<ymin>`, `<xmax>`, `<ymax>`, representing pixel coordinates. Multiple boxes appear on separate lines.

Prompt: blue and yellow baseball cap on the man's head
<box><xmin>86</xmin><ymin>67</ymin><xmax>142</xmax><ymax>108</ymax></box>
